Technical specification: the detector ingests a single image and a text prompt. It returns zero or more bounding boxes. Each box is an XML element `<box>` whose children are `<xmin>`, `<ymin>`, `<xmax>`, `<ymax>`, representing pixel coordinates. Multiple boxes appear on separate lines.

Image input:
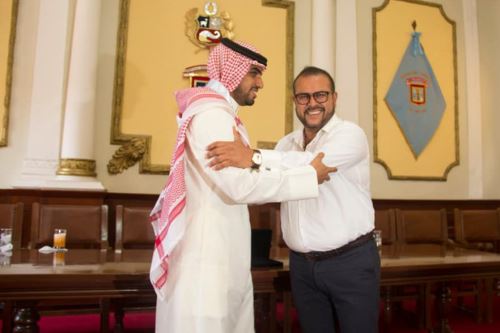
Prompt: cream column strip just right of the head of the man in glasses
<box><xmin>335</xmin><ymin>0</ymin><xmax>359</xmax><ymax>123</ymax></box>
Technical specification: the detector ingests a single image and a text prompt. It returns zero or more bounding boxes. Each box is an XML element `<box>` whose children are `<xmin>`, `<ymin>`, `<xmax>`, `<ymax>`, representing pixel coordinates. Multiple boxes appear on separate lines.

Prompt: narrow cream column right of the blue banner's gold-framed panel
<box><xmin>462</xmin><ymin>0</ymin><xmax>483</xmax><ymax>199</ymax></box>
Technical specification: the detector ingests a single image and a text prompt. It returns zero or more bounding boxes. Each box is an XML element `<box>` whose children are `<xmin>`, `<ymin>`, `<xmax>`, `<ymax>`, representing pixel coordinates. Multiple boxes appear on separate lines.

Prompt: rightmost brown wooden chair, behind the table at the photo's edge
<box><xmin>454</xmin><ymin>208</ymin><xmax>500</xmax><ymax>322</ymax></box>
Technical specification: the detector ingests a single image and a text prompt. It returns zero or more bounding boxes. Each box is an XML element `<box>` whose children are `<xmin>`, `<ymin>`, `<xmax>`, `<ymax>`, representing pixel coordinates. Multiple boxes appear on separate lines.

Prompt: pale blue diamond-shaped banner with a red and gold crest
<box><xmin>385</xmin><ymin>32</ymin><xmax>446</xmax><ymax>158</ymax></box>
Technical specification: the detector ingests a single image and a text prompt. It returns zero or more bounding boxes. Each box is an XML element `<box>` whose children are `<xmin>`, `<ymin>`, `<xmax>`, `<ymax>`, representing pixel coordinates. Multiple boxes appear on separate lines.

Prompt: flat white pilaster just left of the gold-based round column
<box><xmin>12</xmin><ymin>0</ymin><xmax>69</xmax><ymax>188</ymax></box>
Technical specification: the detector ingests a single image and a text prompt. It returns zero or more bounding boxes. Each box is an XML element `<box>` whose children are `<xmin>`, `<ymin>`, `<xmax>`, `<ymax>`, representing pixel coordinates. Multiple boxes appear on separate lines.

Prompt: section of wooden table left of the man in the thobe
<box><xmin>0</xmin><ymin>249</ymin><xmax>154</xmax><ymax>332</ymax></box>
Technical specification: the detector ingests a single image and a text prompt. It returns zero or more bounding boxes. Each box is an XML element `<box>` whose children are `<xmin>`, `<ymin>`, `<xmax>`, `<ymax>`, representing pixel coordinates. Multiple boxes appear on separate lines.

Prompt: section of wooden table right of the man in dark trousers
<box><xmin>381</xmin><ymin>245</ymin><xmax>500</xmax><ymax>332</ymax></box>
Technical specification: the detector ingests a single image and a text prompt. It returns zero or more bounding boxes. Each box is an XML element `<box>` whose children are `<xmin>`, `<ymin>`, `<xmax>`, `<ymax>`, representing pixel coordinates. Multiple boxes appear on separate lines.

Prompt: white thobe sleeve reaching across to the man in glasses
<box><xmin>186</xmin><ymin>103</ymin><xmax>318</xmax><ymax>204</ymax></box>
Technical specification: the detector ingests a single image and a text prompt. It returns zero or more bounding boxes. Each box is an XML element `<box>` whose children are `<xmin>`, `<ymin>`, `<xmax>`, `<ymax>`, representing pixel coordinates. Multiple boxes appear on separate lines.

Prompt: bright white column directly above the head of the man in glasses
<box><xmin>311</xmin><ymin>0</ymin><xmax>336</xmax><ymax>78</ymax></box>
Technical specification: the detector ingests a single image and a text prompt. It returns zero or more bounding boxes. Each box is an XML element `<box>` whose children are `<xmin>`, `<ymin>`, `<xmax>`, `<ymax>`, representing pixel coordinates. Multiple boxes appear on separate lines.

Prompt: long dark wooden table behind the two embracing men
<box><xmin>0</xmin><ymin>245</ymin><xmax>500</xmax><ymax>333</ymax></box>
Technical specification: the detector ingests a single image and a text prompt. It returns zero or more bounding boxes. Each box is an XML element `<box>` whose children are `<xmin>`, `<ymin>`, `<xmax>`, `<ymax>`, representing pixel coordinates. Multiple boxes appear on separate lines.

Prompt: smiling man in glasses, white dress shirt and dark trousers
<box><xmin>207</xmin><ymin>67</ymin><xmax>380</xmax><ymax>333</ymax></box>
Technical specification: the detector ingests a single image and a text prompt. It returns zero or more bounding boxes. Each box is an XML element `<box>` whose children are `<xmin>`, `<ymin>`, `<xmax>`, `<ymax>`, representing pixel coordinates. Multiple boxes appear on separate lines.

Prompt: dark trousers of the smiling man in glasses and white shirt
<box><xmin>290</xmin><ymin>240</ymin><xmax>380</xmax><ymax>333</ymax></box>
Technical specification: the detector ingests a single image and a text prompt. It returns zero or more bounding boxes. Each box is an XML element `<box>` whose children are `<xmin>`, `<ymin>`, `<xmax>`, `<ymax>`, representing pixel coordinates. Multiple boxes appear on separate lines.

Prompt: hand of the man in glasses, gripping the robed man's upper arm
<box><xmin>206</xmin><ymin>127</ymin><xmax>253</xmax><ymax>170</ymax></box>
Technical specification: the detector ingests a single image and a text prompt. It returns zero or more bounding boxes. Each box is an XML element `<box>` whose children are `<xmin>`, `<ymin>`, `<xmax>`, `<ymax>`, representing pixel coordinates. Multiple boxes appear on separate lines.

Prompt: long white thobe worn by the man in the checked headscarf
<box><xmin>156</xmin><ymin>92</ymin><xmax>318</xmax><ymax>333</ymax></box>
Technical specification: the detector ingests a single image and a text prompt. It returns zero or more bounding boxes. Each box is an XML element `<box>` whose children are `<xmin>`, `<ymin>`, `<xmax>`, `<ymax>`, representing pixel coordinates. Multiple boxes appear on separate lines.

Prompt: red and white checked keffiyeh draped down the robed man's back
<box><xmin>150</xmin><ymin>39</ymin><xmax>265</xmax><ymax>299</ymax></box>
